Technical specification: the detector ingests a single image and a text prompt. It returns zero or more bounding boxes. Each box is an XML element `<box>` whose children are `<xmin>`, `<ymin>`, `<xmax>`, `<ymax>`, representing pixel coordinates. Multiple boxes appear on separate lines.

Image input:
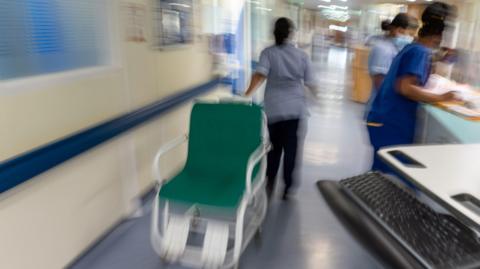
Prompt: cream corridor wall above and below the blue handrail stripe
<box><xmin>0</xmin><ymin>0</ymin><xmax>223</xmax><ymax>269</ymax></box>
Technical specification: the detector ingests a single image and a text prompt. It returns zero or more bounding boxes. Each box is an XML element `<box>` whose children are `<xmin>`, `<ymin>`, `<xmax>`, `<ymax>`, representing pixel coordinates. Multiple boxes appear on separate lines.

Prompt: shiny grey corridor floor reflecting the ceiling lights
<box><xmin>71</xmin><ymin>48</ymin><xmax>382</xmax><ymax>269</ymax></box>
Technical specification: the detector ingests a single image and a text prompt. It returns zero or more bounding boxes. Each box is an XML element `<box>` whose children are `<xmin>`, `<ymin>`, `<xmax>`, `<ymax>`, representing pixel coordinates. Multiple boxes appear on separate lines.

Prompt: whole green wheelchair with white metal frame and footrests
<box><xmin>151</xmin><ymin>103</ymin><xmax>269</xmax><ymax>268</ymax></box>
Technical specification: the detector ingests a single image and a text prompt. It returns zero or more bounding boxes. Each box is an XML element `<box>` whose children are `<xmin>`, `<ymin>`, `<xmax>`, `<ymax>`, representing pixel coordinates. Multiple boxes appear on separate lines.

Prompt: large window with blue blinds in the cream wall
<box><xmin>0</xmin><ymin>0</ymin><xmax>109</xmax><ymax>80</ymax></box>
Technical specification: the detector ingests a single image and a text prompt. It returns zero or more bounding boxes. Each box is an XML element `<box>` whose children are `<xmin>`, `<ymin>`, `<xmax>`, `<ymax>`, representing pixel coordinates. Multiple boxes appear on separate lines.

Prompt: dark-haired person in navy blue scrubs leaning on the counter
<box><xmin>367</xmin><ymin>2</ymin><xmax>458</xmax><ymax>173</ymax></box>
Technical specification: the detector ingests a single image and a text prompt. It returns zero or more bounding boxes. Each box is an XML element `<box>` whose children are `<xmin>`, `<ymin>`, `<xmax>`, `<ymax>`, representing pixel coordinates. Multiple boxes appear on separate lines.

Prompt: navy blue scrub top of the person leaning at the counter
<box><xmin>368</xmin><ymin>43</ymin><xmax>432</xmax><ymax>137</ymax></box>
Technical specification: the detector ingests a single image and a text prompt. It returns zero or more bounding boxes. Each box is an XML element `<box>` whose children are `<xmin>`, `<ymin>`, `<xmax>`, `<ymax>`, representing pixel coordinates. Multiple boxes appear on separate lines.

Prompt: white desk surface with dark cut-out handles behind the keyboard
<box><xmin>378</xmin><ymin>144</ymin><xmax>480</xmax><ymax>227</ymax></box>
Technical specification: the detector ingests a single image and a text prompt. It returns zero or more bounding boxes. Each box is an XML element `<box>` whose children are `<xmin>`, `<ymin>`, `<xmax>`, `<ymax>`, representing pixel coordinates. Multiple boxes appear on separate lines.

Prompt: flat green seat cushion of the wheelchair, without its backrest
<box><xmin>160</xmin><ymin>169</ymin><xmax>258</xmax><ymax>209</ymax></box>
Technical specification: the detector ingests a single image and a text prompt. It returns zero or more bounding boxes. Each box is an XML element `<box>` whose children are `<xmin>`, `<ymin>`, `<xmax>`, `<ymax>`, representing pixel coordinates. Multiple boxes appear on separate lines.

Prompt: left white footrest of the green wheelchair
<box><xmin>162</xmin><ymin>215</ymin><xmax>191</xmax><ymax>262</ymax></box>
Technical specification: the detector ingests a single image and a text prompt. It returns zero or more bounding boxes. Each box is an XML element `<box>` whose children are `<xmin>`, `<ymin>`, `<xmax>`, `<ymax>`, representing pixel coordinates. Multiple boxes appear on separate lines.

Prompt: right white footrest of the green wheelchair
<box><xmin>202</xmin><ymin>221</ymin><xmax>229</xmax><ymax>269</ymax></box>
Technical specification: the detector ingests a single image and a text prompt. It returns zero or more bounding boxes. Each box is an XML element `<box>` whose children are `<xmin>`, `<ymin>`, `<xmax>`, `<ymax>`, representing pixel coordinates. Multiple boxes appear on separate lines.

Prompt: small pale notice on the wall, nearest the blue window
<box><xmin>125</xmin><ymin>3</ymin><xmax>147</xmax><ymax>43</ymax></box>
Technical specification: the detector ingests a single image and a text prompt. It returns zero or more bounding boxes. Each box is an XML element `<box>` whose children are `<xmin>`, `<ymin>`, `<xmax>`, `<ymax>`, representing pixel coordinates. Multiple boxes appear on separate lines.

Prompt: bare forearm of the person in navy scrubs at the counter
<box><xmin>397</xmin><ymin>76</ymin><xmax>457</xmax><ymax>103</ymax></box>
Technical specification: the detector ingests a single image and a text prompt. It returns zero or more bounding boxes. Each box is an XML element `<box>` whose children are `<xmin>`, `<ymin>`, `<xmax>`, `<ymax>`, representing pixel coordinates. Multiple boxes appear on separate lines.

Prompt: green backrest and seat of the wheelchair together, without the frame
<box><xmin>159</xmin><ymin>103</ymin><xmax>263</xmax><ymax>209</ymax></box>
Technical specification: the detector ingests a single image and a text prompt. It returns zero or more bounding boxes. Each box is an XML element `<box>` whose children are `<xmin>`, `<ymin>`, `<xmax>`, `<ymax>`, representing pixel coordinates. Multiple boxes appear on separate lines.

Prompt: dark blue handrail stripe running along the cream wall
<box><xmin>0</xmin><ymin>78</ymin><xmax>221</xmax><ymax>193</ymax></box>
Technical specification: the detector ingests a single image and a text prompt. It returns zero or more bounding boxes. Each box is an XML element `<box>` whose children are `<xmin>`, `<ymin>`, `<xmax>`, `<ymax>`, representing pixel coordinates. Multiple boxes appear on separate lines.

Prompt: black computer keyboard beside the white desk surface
<box><xmin>340</xmin><ymin>173</ymin><xmax>480</xmax><ymax>269</ymax></box>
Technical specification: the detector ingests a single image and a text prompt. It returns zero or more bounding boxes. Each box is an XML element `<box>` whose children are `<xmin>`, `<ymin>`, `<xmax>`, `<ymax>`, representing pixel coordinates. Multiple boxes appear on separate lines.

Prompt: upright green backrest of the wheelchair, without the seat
<box><xmin>185</xmin><ymin>103</ymin><xmax>264</xmax><ymax>180</ymax></box>
